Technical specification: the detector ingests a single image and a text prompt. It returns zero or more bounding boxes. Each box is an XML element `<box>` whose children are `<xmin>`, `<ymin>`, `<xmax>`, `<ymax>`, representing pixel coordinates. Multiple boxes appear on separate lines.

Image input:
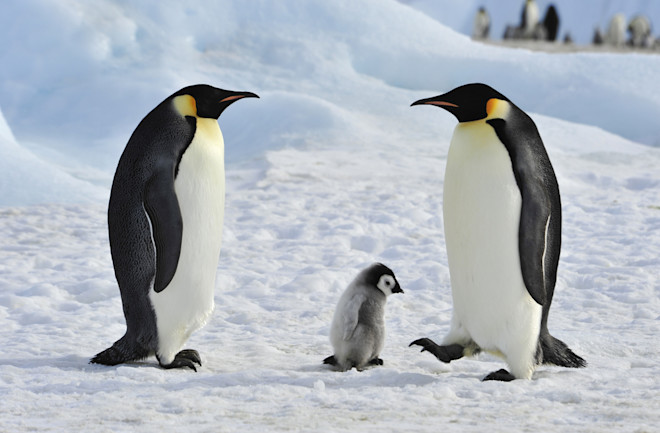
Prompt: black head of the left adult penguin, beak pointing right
<box><xmin>171</xmin><ymin>84</ymin><xmax>259</xmax><ymax>119</ymax></box>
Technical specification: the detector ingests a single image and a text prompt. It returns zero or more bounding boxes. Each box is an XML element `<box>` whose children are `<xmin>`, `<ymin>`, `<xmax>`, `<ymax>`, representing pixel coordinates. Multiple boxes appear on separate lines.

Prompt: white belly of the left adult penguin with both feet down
<box><xmin>150</xmin><ymin>118</ymin><xmax>225</xmax><ymax>364</ymax></box>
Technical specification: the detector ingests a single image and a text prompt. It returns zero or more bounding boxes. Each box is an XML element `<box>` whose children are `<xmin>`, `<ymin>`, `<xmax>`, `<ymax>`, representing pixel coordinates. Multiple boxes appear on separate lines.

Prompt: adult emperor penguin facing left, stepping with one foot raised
<box><xmin>411</xmin><ymin>84</ymin><xmax>586</xmax><ymax>381</ymax></box>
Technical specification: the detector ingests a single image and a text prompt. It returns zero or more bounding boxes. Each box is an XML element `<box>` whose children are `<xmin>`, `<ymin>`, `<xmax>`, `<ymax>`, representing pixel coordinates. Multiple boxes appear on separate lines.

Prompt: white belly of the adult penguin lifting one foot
<box><xmin>443</xmin><ymin>121</ymin><xmax>541</xmax><ymax>378</ymax></box>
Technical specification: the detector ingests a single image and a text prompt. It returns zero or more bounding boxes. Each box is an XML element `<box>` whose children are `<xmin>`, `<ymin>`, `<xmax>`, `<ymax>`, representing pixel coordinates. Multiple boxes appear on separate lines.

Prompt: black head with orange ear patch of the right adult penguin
<box><xmin>411</xmin><ymin>83</ymin><xmax>509</xmax><ymax>123</ymax></box>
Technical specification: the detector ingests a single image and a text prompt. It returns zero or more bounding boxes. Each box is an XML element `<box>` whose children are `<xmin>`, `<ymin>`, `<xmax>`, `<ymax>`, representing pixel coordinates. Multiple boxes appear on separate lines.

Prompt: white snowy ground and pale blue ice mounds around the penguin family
<box><xmin>0</xmin><ymin>0</ymin><xmax>660</xmax><ymax>432</ymax></box>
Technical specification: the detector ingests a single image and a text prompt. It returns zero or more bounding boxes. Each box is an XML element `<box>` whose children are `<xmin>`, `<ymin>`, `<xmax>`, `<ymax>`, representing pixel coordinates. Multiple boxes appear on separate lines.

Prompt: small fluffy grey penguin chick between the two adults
<box><xmin>323</xmin><ymin>263</ymin><xmax>403</xmax><ymax>371</ymax></box>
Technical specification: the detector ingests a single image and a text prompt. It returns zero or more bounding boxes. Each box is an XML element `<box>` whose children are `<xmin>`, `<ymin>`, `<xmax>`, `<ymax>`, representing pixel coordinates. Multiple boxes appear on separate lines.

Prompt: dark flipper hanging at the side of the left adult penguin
<box><xmin>144</xmin><ymin>170</ymin><xmax>183</xmax><ymax>293</ymax></box>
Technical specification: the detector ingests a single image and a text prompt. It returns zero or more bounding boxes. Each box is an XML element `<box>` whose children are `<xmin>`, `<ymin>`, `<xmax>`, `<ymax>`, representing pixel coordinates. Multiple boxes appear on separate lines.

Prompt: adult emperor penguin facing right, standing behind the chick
<box><xmin>91</xmin><ymin>85</ymin><xmax>258</xmax><ymax>371</ymax></box>
